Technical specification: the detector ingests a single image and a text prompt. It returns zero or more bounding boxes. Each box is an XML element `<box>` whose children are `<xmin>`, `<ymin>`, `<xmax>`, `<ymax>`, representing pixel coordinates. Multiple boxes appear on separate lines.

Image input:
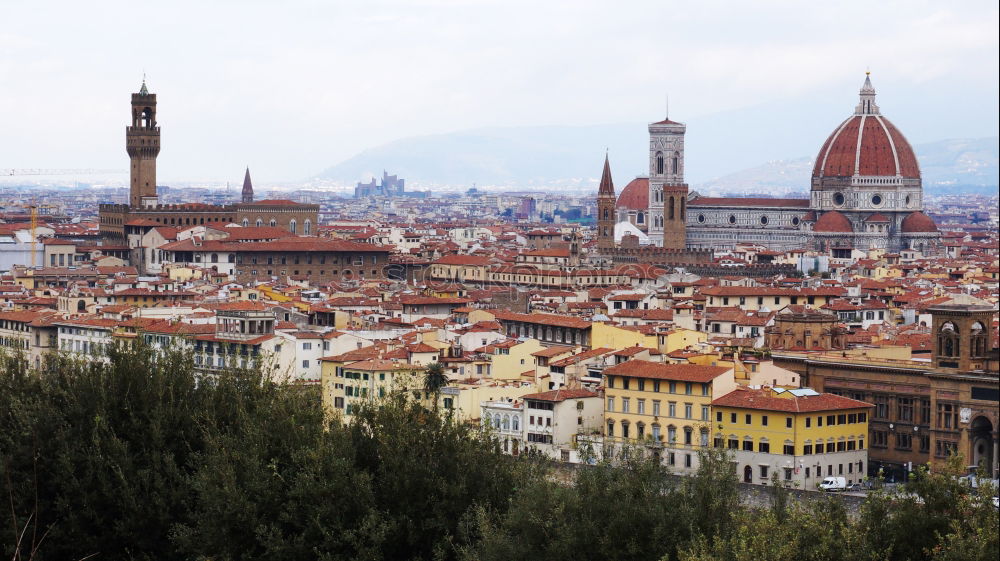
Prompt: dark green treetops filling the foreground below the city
<box><xmin>0</xmin><ymin>342</ymin><xmax>1000</xmax><ymax>561</ymax></box>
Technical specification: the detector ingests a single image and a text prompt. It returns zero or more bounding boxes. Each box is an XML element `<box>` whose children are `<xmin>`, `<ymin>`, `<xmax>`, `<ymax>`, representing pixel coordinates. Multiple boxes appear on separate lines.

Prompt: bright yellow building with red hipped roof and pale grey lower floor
<box><xmin>712</xmin><ymin>388</ymin><xmax>873</xmax><ymax>489</ymax></box>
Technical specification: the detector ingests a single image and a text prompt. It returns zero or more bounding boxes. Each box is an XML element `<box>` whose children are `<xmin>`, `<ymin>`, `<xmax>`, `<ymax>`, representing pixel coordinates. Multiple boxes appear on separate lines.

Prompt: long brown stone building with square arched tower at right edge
<box><xmin>772</xmin><ymin>296</ymin><xmax>1000</xmax><ymax>480</ymax></box>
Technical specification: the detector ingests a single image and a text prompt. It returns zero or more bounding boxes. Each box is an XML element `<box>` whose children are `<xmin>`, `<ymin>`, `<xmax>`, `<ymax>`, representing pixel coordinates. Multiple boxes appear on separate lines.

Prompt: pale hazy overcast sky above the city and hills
<box><xmin>0</xmin><ymin>0</ymin><xmax>998</xmax><ymax>183</ymax></box>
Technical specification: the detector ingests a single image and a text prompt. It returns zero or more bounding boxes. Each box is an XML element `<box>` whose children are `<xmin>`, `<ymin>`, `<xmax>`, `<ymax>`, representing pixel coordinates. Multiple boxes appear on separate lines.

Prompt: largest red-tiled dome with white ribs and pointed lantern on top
<box><xmin>813</xmin><ymin>77</ymin><xmax>920</xmax><ymax>179</ymax></box>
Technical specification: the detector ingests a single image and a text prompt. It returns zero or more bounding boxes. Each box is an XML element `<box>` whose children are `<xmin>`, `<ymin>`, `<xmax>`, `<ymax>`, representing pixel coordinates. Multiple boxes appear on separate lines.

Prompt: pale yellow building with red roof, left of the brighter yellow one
<box><xmin>604</xmin><ymin>360</ymin><xmax>736</xmax><ymax>473</ymax></box>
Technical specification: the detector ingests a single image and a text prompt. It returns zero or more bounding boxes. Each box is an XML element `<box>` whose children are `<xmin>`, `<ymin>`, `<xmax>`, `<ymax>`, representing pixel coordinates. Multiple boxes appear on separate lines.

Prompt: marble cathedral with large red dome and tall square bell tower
<box><xmin>598</xmin><ymin>74</ymin><xmax>941</xmax><ymax>258</ymax></box>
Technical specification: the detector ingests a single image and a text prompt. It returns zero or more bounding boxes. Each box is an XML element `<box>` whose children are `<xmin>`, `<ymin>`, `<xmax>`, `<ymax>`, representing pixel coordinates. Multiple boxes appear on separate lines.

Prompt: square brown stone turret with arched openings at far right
<box><xmin>927</xmin><ymin>294</ymin><xmax>996</xmax><ymax>372</ymax></box>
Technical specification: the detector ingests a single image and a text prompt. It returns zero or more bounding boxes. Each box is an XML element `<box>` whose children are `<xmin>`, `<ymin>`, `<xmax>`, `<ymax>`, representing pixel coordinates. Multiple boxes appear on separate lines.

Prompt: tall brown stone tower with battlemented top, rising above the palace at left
<box><xmin>125</xmin><ymin>80</ymin><xmax>160</xmax><ymax>208</ymax></box>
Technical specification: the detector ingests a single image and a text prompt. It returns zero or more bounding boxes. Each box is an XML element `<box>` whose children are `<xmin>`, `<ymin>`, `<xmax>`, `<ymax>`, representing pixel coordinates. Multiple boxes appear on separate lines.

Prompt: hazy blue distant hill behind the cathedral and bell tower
<box><xmin>315</xmin><ymin>112</ymin><xmax>998</xmax><ymax>195</ymax></box>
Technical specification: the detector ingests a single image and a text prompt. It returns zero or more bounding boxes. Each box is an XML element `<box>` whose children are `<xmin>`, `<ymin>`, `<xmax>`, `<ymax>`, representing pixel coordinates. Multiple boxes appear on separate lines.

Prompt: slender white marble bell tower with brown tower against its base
<box><xmin>649</xmin><ymin>115</ymin><xmax>688</xmax><ymax>249</ymax></box>
